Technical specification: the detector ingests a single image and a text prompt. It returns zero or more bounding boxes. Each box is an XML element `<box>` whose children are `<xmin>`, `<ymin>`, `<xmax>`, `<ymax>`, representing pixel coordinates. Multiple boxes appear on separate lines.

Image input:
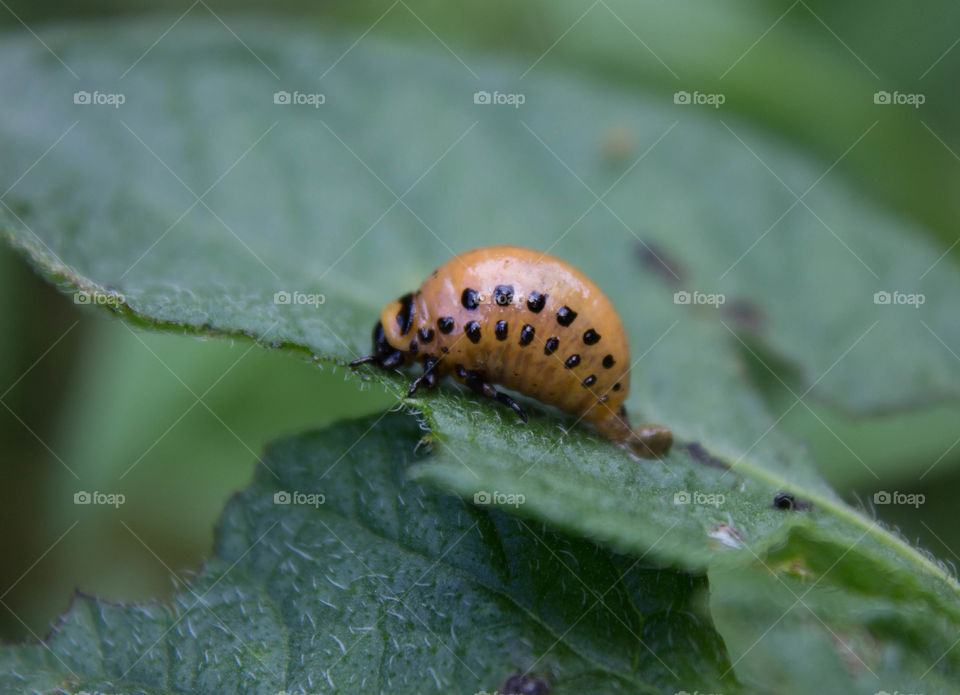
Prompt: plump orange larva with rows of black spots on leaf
<box><xmin>350</xmin><ymin>246</ymin><xmax>673</xmax><ymax>458</ymax></box>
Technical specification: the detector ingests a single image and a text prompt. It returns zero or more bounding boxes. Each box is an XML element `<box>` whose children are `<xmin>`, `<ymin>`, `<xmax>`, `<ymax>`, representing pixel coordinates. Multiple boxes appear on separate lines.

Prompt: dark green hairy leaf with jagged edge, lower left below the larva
<box><xmin>0</xmin><ymin>414</ymin><xmax>735</xmax><ymax>695</ymax></box>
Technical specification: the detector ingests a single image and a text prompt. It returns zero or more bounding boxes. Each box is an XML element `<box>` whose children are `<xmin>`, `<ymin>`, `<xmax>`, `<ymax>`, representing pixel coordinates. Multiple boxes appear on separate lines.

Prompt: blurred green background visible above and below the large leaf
<box><xmin>0</xmin><ymin>0</ymin><xmax>960</xmax><ymax>640</ymax></box>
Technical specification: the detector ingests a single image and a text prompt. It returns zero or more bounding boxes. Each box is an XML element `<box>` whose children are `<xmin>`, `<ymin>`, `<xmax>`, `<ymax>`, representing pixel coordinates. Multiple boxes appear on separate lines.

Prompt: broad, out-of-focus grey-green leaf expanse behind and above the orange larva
<box><xmin>0</xmin><ymin>21</ymin><xmax>960</xmax><ymax>416</ymax></box>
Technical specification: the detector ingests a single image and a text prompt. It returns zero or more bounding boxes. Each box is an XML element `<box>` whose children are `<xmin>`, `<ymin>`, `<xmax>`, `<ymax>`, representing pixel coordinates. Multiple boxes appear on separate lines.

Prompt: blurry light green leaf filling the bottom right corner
<box><xmin>710</xmin><ymin>561</ymin><xmax>960</xmax><ymax>695</ymax></box>
